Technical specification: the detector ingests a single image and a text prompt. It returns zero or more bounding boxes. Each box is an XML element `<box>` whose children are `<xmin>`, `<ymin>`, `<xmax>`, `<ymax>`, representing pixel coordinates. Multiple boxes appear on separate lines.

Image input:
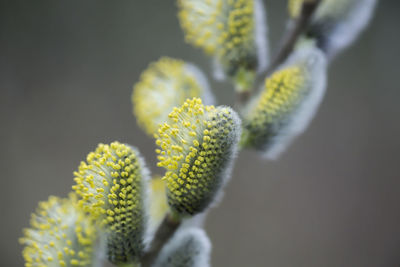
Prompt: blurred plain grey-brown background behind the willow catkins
<box><xmin>0</xmin><ymin>0</ymin><xmax>400</xmax><ymax>267</ymax></box>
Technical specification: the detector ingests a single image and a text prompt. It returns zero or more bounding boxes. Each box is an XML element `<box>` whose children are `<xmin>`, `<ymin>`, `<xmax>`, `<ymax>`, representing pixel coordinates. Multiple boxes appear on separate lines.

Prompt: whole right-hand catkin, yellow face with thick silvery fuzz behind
<box><xmin>242</xmin><ymin>47</ymin><xmax>326</xmax><ymax>159</ymax></box>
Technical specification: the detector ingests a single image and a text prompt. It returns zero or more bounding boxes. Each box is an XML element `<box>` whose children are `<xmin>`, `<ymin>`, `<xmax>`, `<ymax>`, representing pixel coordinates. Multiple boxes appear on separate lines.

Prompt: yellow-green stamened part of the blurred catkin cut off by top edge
<box><xmin>178</xmin><ymin>0</ymin><xmax>257</xmax><ymax>76</ymax></box>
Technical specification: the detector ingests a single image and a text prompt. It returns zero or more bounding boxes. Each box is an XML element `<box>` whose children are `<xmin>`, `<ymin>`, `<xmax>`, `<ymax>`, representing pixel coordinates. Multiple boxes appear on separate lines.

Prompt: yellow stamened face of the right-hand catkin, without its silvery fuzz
<box><xmin>244</xmin><ymin>66</ymin><xmax>310</xmax><ymax>149</ymax></box>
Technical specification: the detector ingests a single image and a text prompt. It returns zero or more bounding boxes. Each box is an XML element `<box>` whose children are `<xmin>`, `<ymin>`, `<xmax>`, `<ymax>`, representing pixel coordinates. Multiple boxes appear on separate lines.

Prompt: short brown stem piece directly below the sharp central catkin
<box><xmin>141</xmin><ymin>213</ymin><xmax>181</xmax><ymax>267</ymax></box>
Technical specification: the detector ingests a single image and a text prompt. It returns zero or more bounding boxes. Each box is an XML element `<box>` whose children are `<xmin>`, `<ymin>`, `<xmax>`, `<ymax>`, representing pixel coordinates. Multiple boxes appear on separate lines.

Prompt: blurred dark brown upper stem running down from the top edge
<box><xmin>237</xmin><ymin>0</ymin><xmax>321</xmax><ymax>106</ymax></box>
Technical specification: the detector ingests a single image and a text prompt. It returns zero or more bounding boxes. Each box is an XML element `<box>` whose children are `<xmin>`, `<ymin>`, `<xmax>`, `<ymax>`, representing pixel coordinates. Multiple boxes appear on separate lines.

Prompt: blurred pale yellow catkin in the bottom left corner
<box><xmin>20</xmin><ymin>194</ymin><xmax>97</xmax><ymax>267</ymax></box>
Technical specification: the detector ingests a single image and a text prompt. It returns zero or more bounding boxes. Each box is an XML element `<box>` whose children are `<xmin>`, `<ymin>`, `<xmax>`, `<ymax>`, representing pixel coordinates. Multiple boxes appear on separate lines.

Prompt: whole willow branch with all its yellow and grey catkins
<box><xmin>21</xmin><ymin>0</ymin><xmax>376</xmax><ymax>267</ymax></box>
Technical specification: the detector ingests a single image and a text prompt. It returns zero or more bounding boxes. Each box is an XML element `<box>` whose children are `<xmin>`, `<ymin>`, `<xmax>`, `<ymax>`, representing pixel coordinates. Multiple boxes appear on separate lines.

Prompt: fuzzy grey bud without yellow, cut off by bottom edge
<box><xmin>154</xmin><ymin>228</ymin><xmax>211</xmax><ymax>267</ymax></box>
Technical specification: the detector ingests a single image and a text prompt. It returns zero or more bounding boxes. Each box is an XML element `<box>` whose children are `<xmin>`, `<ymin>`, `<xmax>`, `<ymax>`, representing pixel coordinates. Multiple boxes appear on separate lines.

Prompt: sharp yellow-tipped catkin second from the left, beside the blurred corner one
<box><xmin>72</xmin><ymin>142</ymin><xmax>148</xmax><ymax>263</ymax></box>
